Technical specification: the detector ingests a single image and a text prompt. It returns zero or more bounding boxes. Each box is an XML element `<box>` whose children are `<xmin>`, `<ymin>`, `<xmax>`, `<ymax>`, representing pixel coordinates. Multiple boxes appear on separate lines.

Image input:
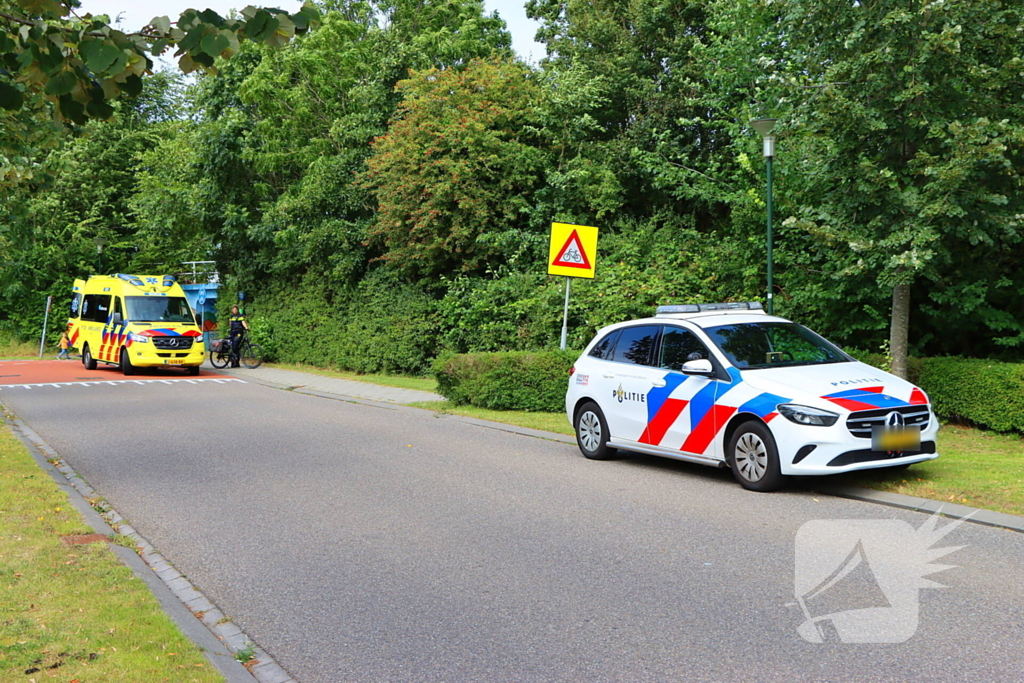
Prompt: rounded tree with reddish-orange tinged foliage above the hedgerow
<box><xmin>365</xmin><ymin>58</ymin><xmax>547</xmax><ymax>278</ymax></box>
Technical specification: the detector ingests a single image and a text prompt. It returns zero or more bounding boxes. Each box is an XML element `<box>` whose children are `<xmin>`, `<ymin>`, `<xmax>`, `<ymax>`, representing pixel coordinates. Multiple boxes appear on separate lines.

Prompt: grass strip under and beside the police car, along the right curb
<box><xmin>411</xmin><ymin>401</ymin><xmax>1024</xmax><ymax>516</ymax></box>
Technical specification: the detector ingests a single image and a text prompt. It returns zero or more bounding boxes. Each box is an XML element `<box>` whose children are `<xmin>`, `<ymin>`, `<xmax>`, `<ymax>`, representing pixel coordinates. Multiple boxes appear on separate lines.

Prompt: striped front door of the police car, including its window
<box><xmin>650</xmin><ymin>326</ymin><xmax>721</xmax><ymax>456</ymax></box>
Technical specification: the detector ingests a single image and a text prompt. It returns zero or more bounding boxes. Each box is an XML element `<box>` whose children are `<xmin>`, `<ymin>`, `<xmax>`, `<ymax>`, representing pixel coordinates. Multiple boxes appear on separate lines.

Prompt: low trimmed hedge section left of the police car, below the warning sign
<box><xmin>433</xmin><ymin>351</ymin><xmax>580</xmax><ymax>413</ymax></box>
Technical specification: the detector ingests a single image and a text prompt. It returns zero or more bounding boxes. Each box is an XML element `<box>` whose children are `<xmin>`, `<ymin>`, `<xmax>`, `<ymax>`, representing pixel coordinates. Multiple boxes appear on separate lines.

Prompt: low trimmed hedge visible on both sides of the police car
<box><xmin>434</xmin><ymin>351</ymin><xmax>1024</xmax><ymax>432</ymax></box>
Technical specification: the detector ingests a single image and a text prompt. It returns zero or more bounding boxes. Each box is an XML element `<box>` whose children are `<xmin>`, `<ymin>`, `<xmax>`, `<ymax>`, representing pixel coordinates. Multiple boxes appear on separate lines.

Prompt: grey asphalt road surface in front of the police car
<box><xmin>0</xmin><ymin>381</ymin><xmax>1024</xmax><ymax>683</ymax></box>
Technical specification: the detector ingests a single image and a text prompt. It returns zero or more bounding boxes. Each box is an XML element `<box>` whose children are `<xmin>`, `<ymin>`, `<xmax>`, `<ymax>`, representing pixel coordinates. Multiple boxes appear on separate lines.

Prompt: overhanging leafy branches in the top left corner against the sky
<box><xmin>0</xmin><ymin>0</ymin><xmax>318</xmax><ymax>186</ymax></box>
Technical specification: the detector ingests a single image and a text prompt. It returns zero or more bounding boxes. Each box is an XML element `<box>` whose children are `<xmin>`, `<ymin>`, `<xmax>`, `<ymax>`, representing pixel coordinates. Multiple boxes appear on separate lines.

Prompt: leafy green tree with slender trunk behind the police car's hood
<box><xmin>766</xmin><ymin>0</ymin><xmax>1024</xmax><ymax>376</ymax></box>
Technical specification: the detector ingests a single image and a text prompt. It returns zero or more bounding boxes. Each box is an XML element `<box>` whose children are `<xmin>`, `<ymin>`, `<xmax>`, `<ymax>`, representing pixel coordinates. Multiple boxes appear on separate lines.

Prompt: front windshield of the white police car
<box><xmin>705</xmin><ymin>323</ymin><xmax>851</xmax><ymax>370</ymax></box>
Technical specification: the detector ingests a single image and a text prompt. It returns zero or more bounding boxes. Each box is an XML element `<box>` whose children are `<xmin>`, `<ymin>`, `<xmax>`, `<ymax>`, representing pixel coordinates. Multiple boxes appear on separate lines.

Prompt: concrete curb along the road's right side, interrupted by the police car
<box><xmin>228</xmin><ymin>371</ymin><xmax>1024</xmax><ymax>533</ymax></box>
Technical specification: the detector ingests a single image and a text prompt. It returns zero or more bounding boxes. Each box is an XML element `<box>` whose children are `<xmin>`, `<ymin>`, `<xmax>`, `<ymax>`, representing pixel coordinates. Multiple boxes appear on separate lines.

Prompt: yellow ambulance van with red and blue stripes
<box><xmin>68</xmin><ymin>273</ymin><xmax>205</xmax><ymax>375</ymax></box>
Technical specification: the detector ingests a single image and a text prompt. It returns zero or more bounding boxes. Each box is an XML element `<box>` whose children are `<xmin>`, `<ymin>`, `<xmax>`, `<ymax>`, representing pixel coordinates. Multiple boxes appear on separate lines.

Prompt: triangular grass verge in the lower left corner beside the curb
<box><xmin>0</xmin><ymin>425</ymin><xmax>224</xmax><ymax>683</ymax></box>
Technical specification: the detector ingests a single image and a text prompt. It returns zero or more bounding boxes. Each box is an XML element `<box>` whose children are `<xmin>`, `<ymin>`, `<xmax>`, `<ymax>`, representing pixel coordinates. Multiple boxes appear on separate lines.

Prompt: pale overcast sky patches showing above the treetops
<box><xmin>81</xmin><ymin>0</ymin><xmax>544</xmax><ymax>63</ymax></box>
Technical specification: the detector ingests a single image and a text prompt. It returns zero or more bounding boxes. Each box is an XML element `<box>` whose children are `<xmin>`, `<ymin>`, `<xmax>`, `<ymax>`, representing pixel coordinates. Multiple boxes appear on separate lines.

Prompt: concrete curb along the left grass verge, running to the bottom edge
<box><xmin>6</xmin><ymin>415</ymin><xmax>296</xmax><ymax>683</ymax></box>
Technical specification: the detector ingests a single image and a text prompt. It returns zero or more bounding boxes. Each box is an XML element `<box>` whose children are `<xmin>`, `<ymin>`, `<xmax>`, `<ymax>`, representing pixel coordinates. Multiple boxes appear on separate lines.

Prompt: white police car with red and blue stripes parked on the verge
<box><xmin>565</xmin><ymin>302</ymin><xmax>939</xmax><ymax>490</ymax></box>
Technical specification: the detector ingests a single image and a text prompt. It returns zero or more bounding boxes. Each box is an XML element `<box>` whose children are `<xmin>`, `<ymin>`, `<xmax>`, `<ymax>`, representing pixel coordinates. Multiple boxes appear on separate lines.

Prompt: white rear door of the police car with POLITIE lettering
<box><xmin>601</xmin><ymin>325</ymin><xmax>665</xmax><ymax>441</ymax></box>
